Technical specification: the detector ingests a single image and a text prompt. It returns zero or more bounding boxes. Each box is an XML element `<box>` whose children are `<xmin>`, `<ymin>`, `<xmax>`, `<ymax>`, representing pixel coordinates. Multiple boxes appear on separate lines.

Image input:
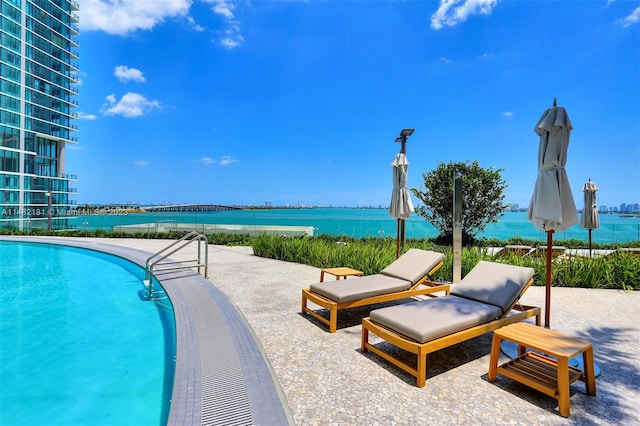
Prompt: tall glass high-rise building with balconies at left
<box><xmin>0</xmin><ymin>0</ymin><xmax>78</xmax><ymax>230</ymax></box>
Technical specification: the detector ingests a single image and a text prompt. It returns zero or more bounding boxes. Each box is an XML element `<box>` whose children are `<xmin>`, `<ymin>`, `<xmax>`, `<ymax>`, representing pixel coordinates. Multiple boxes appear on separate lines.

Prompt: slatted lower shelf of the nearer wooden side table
<box><xmin>498</xmin><ymin>352</ymin><xmax>583</xmax><ymax>398</ymax></box>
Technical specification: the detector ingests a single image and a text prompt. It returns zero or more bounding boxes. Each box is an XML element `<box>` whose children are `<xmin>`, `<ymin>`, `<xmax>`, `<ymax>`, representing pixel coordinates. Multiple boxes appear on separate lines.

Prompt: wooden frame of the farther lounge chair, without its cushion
<box><xmin>300</xmin><ymin>262</ymin><xmax>450</xmax><ymax>333</ymax></box>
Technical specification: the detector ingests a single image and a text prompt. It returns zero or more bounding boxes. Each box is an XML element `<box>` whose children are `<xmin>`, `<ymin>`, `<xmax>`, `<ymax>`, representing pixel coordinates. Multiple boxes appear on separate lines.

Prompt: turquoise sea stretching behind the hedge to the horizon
<box><xmin>72</xmin><ymin>207</ymin><xmax>640</xmax><ymax>244</ymax></box>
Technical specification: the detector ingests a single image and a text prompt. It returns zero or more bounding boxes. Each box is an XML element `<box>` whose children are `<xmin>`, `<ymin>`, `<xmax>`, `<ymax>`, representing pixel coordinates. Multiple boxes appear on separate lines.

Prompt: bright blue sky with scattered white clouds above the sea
<box><xmin>72</xmin><ymin>0</ymin><xmax>640</xmax><ymax>208</ymax></box>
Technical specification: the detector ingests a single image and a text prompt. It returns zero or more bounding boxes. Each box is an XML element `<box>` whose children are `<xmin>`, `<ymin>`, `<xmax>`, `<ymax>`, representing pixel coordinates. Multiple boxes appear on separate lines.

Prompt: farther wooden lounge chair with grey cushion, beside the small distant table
<box><xmin>301</xmin><ymin>248</ymin><xmax>449</xmax><ymax>333</ymax></box>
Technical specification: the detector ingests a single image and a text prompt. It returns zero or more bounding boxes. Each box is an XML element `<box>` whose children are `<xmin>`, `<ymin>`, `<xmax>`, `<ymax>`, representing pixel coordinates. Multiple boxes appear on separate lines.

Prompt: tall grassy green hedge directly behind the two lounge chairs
<box><xmin>250</xmin><ymin>235</ymin><xmax>640</xmax><ymax>290</ymax></box>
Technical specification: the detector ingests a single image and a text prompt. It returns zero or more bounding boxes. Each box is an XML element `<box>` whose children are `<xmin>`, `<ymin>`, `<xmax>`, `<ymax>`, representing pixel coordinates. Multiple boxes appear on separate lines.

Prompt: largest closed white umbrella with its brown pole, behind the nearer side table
<box><xmin>527</xmin><ymin>99</ymin><xmax>578</xmax><ymax>328</ymax></box>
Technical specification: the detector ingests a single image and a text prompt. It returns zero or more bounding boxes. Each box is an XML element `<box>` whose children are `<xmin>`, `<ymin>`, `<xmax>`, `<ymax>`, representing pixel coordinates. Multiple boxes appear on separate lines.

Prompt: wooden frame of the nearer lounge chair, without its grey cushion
<box><xmin>361</xmin><ymin>278</ymin><xmax>541</xmax><ymax>388</ymax></box>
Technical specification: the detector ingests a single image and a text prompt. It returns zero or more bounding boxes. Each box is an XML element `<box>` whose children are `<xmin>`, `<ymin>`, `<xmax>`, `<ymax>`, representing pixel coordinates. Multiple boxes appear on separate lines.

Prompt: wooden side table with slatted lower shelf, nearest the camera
<box><xmin>488</xmin><ymin>322</ymin><xmax>596</xmax><ymax>417</ymax></box>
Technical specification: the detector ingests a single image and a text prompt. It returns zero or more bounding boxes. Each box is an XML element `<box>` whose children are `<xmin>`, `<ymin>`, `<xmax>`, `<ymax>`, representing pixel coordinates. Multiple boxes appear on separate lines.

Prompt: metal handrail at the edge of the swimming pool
<box><xmin>143</xmin><ymin>231</ymin><xmax>209</xmax><ymax>300</ymax></box>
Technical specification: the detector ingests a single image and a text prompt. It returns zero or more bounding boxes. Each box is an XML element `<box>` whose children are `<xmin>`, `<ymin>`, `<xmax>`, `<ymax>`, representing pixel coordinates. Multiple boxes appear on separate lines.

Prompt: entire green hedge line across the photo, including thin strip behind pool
<box><xmin>0</xmin><ymin>229</ymin><xmax>640</xmax><ymax>290</ymax></box>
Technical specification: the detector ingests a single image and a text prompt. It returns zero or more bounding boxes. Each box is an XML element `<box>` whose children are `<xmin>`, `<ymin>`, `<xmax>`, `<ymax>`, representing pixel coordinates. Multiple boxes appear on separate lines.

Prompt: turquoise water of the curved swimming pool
<box><xmin>0</xmin><ymin>241</ymin><xmax>175</xmax><ymax>426</ymax></box>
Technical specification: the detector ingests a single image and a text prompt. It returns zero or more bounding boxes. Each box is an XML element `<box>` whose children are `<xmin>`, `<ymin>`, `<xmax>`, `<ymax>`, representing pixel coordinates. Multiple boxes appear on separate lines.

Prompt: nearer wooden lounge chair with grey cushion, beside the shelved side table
<box><xmin>361</xmin><ymin>261</ymin><xmax>540</xmax><ymax>387</ymax></box>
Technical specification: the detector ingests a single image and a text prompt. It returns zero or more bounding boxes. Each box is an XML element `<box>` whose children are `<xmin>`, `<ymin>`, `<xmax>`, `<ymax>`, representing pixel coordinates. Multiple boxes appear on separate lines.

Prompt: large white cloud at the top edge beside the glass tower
<box><xmin>77</xmin><ymin>0</ymin><xmax>193</xmax><ymax>35</ymax></box>
